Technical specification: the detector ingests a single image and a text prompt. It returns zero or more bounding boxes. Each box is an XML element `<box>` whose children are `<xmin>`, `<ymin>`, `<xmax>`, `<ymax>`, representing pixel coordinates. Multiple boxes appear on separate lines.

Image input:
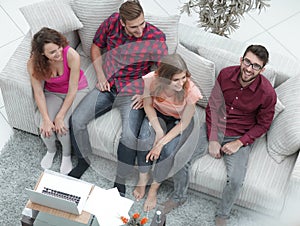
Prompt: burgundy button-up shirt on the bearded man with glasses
<box><xmin>206</xmin><ymin>66</ymin><xmax>277</xmax><ymax>146</ymax></box>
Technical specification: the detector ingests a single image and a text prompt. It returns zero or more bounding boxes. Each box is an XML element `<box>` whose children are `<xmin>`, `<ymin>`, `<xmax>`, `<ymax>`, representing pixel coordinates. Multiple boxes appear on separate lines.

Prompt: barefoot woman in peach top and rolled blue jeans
<box><xmin>133</xmin><ymin>54</ymin><xmax>202</xmax><ymax>211</ymax></box>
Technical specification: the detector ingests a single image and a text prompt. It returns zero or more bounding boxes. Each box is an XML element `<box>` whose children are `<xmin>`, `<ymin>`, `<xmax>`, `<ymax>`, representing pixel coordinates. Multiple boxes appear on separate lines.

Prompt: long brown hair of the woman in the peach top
<box><xmin>150</xmin><ymin>53</ymin><xmax>191</xmax><ymax>102</ymax></box>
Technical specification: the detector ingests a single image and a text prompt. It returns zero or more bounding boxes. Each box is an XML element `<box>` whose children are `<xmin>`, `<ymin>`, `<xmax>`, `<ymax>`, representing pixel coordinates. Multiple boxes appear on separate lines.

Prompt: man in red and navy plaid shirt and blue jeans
<box><xmin>69</xmin><ymin>1</ymin><xmax>168</xmax><ymax>194</ymax></box>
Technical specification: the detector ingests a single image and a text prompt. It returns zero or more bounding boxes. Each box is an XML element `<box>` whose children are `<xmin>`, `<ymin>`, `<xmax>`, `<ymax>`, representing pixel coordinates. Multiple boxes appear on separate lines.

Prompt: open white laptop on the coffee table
<box><xmin>26</xmin><ymin>170</ymin><xmax>93</xmax><ymax>215</ymax></box>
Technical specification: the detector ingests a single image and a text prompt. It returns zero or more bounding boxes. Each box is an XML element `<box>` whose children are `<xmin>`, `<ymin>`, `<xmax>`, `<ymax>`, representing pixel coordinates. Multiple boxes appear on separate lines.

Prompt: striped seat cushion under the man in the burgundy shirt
<box><xmin>190</xmin><ymin>136</ymin><xmax>297</xmax><ymax>214</ymax></box>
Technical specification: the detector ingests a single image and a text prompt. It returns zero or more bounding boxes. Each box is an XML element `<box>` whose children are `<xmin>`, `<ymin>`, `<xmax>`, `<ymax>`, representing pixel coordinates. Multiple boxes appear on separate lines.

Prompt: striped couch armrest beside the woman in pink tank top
<box><xmin>0</xmin><ymin>33</ymin><xmax>38</xmax><ymax>134</ymax></box>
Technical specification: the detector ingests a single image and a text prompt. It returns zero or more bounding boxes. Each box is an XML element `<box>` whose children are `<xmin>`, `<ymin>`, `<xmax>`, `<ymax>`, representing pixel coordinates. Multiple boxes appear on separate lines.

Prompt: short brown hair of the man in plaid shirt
<box><xmin>119</xmin><ymin>0</ymin><xmax>144</xmax><ymax>24</ymax></box>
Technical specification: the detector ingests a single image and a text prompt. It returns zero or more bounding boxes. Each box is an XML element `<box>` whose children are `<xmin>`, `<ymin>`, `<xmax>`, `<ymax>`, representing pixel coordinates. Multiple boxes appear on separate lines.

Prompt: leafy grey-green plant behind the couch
<box><xmin>180</xmin><ymin>0</ymin><xmax>270</xmax><ymax>37</ymax></box>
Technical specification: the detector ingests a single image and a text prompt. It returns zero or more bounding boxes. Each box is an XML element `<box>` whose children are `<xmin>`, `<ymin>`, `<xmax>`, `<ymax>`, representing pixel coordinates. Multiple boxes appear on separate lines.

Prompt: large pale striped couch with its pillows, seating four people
<box><xmin>0</xmin><ymin>0</ymin><xmax>300</xmax><ymax>216</ymax></box>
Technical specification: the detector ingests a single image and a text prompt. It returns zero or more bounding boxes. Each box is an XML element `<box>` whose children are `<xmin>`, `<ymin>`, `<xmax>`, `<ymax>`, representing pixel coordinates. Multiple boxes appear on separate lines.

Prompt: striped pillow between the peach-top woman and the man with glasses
<box><xmin>176</xmin><ymin>44</ymin><xmax>215</xmax><ymax>108</ymax></box>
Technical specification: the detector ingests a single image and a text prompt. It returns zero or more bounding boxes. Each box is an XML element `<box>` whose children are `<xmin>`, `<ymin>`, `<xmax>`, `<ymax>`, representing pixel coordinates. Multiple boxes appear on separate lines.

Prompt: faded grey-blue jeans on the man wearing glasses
<box><xmin>172</xmin><ymin>124</ymin><xmax>252</xmax><ymax>218</ymax></box>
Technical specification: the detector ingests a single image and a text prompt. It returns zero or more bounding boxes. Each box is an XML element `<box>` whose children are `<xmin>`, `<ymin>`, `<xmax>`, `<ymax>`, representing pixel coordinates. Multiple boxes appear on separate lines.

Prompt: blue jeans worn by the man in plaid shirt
<box><xmin>70</xmin><ymin>87</ymin><xmax>145</xmax><ymax>177</ymax></box>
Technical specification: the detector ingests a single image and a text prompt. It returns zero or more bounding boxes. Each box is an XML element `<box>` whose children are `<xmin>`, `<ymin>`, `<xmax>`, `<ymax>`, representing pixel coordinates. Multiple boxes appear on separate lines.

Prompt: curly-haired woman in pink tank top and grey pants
<box><xmin>27</xmin><ymin>27</ymin><xmax>88</xmax><ymax>174</ymax></box>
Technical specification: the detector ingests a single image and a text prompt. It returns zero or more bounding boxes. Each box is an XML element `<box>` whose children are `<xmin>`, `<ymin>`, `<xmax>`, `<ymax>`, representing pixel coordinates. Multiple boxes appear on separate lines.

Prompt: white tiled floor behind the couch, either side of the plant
<box><xmin>140</xmin><ymin>0</ymin><xmax>300</xmax><ymax>61</ymax></box>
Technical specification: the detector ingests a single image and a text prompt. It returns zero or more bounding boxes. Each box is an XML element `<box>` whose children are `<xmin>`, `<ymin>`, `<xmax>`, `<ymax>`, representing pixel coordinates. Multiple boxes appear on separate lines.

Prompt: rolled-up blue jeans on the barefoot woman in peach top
<box><xmin>137</xmin><ymin>111</ymin><xmax>194</xmax><ymax>183</ymax></box>
